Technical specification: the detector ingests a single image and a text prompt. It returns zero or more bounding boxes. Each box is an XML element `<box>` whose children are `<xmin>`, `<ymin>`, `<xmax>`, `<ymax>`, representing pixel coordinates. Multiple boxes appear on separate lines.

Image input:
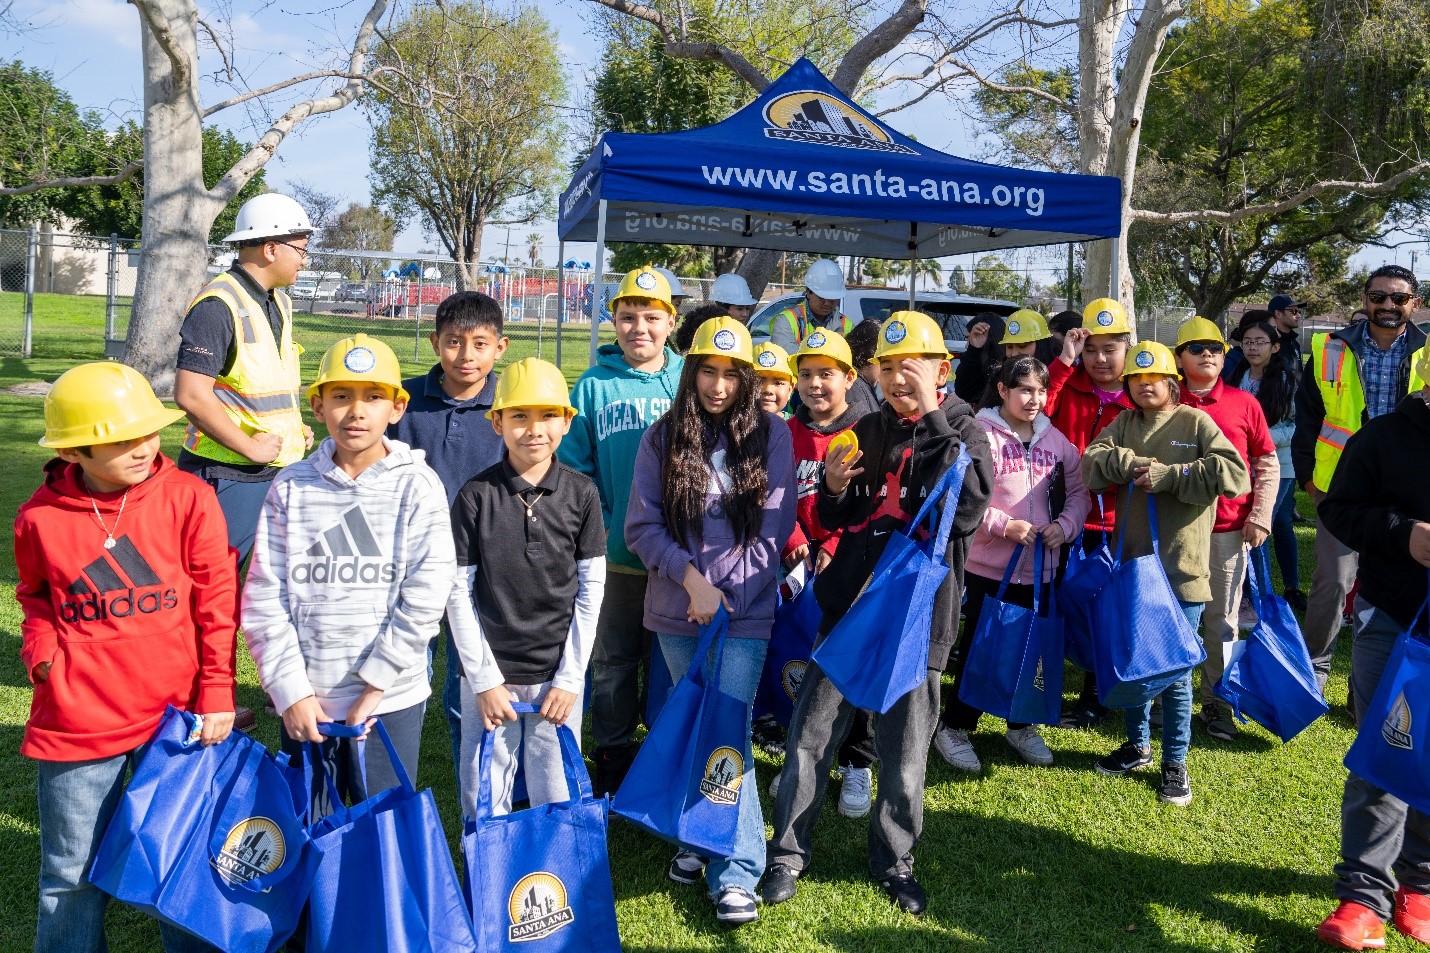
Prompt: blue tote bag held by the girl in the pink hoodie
<box><xmin>958</xmin><ymin>542</ymin><xmax>1062</xmax><ymax>724</ymax></box>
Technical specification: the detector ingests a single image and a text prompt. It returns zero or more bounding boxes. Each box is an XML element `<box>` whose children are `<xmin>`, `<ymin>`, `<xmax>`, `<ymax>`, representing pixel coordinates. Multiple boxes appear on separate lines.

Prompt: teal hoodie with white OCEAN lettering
<box><xmin>556</xmin><ymin>343</ymin><xmax>684</xmax><ymax>571</ymax></box>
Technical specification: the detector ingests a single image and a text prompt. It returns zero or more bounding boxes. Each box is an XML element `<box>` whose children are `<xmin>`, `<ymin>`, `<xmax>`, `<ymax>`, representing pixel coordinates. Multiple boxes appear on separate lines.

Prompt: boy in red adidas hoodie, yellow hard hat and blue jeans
<box><xmin>14</xmin><ymin>362</ymin><xmax>237</xmax><ymax>953</ymax></box>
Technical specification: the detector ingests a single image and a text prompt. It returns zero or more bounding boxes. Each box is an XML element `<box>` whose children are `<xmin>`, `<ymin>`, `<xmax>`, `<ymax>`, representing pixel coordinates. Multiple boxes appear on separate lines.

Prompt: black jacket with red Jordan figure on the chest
<box><xmin>815</xmin><ymin>395</ymin><xmax>992</xmax><ymax>670</ymax></box>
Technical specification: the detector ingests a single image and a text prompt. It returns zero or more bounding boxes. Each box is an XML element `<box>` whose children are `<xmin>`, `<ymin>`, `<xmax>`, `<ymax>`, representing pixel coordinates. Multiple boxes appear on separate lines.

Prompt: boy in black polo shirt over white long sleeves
<box><xmin>448</xmin><ymin>358</ymin><xmax>606</xmax><ymax>817</ymax></box>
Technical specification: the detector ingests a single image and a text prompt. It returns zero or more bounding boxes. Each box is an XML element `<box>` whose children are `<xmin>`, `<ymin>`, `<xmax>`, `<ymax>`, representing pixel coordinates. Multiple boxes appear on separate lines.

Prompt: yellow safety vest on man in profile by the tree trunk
<box><xmin>183</xmin><ymin>272</ymin><xmax>306</xmax><ymax>466</ymax></box>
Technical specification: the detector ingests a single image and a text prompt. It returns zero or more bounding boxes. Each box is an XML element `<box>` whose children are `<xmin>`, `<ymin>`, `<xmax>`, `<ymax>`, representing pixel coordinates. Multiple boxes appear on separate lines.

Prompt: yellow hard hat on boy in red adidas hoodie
<box><xmin>40</xmin><ymin>361</ymin><xmax>183</xmax><ymax>449</ymax></box>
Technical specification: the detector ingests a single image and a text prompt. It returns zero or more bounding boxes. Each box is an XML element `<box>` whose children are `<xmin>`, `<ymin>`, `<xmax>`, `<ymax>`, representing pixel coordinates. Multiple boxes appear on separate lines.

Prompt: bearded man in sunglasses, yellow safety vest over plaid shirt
<box><xmin>1291</xmin><ymin>265</ymin><xmax>1426</xmax><ymax>688</ymax></box>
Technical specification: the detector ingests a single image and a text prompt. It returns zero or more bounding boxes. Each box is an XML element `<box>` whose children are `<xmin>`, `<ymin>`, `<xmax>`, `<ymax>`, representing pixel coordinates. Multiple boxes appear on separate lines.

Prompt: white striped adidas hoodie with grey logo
<box><xmin>242</xmin><ymin>438</ymin><xmax>456</xmax><ymax>720</ymax></box>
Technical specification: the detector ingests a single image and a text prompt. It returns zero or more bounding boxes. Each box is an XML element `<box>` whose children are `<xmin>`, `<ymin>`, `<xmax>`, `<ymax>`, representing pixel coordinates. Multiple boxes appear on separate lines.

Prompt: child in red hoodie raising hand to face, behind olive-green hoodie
<box><xmin>1044</xmin><ymin>298</ymin><xmax>1133</xmax><ymax>728</ymax></box>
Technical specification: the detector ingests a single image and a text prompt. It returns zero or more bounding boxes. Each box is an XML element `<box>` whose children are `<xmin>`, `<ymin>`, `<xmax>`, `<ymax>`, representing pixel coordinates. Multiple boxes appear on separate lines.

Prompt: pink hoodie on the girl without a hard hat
<box><xmin>965</xmin><ymin>408</ymin><xmax>1093</xmax><ymax>585</ymax></box>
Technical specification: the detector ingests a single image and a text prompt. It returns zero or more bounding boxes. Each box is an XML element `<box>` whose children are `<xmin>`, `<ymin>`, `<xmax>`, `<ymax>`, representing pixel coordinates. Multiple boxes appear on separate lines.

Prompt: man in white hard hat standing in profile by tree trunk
<box><xmin>174</xmin><ymin>192</ymin><xmax>313</xmax><ymax>561</ymax></box>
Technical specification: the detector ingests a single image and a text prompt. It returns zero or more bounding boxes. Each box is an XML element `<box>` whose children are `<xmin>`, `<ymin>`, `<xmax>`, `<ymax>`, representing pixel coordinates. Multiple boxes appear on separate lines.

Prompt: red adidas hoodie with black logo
<box><xmin>14</xmin><ymin>455</ymin><xmax>237</xmax><ymax>761</ymax></box>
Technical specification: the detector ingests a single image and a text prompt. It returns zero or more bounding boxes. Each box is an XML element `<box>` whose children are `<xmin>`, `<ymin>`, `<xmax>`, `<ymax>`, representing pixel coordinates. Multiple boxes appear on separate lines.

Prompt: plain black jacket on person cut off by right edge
<box><xmin>1317</xmin><ymin>394</ymin><xmax>1430</xmax><ymax>627</ymax></box>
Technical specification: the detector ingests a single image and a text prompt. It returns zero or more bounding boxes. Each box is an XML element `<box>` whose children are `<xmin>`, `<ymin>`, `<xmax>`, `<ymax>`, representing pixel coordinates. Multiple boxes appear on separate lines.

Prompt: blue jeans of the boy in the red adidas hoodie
<box><xmin>34</xmin><ymin>747</ymin><xmax>215</xmax><ymax>953</ymax></box>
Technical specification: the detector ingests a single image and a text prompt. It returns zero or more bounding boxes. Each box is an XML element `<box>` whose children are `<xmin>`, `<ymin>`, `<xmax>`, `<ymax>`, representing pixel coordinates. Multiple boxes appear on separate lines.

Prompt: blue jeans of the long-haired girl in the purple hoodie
<box><xmin>659</xmin><ymin>634</ymin><xmax>769</xmax><ymax>899</ymax></box>
